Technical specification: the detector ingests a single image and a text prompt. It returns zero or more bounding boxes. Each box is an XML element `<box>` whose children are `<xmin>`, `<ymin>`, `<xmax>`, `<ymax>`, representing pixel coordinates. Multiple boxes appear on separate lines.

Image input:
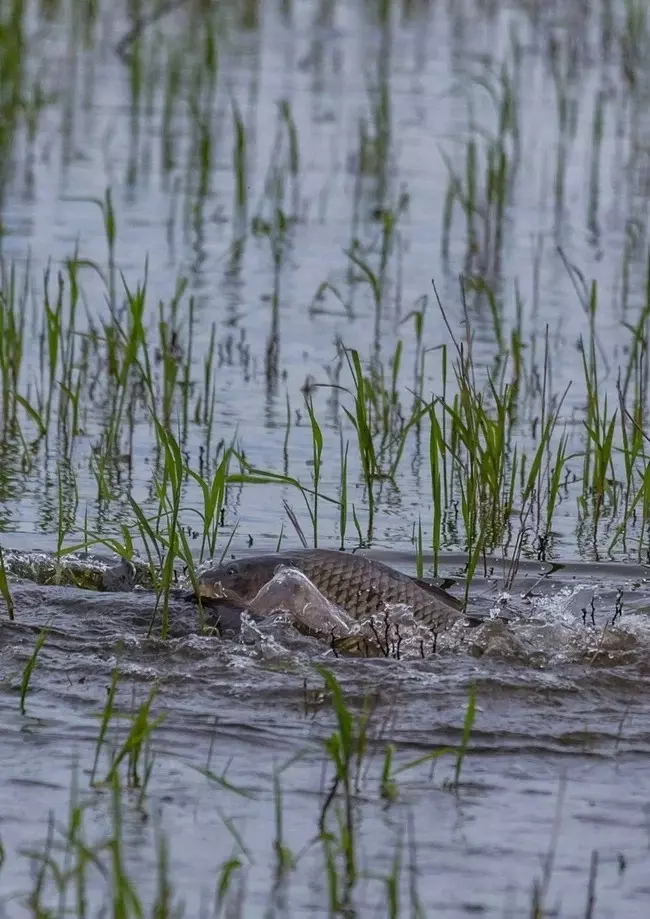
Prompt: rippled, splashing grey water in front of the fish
<box><xmin>0</xmin><ymin>559</ymin><xmax>650</xmax><ymax>917</ymax></box>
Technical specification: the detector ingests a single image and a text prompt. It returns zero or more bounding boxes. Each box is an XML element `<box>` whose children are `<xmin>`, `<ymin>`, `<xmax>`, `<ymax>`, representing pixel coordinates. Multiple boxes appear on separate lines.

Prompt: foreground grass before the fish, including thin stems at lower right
<box><xmin>0</xmin><ymin>666</ymin><xmax>598</xmax><ymax>919</ymax></box>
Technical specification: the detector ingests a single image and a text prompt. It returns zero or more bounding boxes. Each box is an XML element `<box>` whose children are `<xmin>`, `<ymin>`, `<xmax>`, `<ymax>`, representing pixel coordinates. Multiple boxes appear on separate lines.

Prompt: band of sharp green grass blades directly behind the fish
<box><xmin>0</xmin><ymin>234</ymin><xmax>648</xmax><ymax>600</ymax></box>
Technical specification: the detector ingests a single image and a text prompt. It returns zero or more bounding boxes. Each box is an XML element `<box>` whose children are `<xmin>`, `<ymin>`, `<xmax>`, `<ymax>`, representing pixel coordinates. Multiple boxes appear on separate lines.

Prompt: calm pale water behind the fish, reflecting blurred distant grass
<box><xmin>1</xmin><ymin>0</ymin><xmax>647</xmax><ymax>558</ymax></box>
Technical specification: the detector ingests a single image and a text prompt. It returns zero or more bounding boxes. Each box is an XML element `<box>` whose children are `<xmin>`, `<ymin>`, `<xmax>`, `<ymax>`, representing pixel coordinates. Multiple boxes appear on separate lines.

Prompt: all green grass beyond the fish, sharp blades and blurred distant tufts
<box><xmin>0</xmin><ymin>8</ymin><xmax>648</xmax><ymax>584</ymax></box>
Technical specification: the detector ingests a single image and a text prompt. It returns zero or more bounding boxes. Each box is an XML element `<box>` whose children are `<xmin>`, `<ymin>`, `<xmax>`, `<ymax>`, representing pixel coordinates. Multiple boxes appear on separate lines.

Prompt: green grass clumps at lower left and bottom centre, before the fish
<box><xmin>0</xmin><ymin>667</ymin><xmax>475</xmax><ymax>919</ymax></box>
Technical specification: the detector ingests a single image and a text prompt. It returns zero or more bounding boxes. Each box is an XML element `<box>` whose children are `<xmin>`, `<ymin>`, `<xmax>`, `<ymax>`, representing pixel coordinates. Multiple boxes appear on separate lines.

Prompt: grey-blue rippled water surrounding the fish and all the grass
<box><xmin>0</xmin><ymin>0</ymin><xmax>650</xmax><ymax>919</ymax></box>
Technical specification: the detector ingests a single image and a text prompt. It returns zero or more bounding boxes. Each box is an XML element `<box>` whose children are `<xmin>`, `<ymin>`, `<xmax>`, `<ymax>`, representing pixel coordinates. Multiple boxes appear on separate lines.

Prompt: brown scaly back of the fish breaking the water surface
<box><xmin>199</xmin><ymin>549</ymin><xmax>463</xmax><ymax>631</ymax></box>
